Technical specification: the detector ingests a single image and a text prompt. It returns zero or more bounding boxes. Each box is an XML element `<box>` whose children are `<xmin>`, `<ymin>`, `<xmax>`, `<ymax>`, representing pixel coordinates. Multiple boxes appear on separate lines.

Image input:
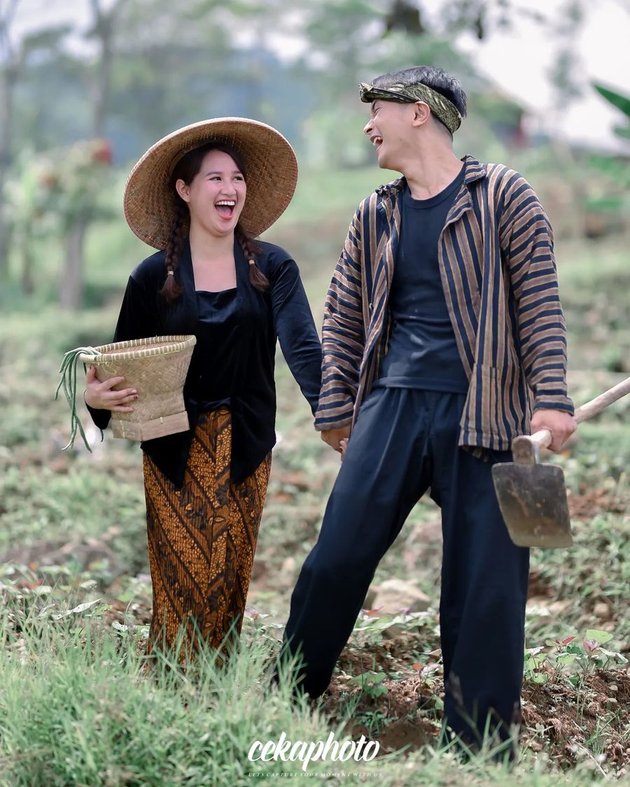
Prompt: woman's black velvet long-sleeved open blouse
<box><xmin>90</xmin><ymin>241</ymin><xmax>322</xmax><ymax>487</ymax></box>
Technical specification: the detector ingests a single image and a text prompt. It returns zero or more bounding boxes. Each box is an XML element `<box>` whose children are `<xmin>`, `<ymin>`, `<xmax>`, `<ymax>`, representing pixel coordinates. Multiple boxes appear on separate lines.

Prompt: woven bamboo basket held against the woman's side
<box><xmin>79</xmin><ymin>336</ymin><xmax>197</xmax><ymax>440</ymax></box>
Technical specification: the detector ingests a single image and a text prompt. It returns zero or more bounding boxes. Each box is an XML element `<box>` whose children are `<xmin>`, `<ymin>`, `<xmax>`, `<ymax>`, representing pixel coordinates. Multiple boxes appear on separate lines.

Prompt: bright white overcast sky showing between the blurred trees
<box><xmin>9</xmin><ymin>0</ymin><xmax>630</xmax><ymax>149</ymax></box>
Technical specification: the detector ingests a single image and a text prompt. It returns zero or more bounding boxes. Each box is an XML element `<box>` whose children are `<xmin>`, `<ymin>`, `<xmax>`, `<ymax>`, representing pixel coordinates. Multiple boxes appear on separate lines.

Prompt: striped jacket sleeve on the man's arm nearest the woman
<box><xmin>315</xmin><ymin>202</ymin><xmax>366</xmax><ymax>431</ymax></box>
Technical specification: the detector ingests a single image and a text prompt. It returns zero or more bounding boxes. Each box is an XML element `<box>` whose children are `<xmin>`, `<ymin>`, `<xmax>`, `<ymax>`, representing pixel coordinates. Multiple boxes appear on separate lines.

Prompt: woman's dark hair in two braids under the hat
<box><xmin>160</xmin><ymin>142</ymin><xmax>270</xmax><ymax>302</ymax></box>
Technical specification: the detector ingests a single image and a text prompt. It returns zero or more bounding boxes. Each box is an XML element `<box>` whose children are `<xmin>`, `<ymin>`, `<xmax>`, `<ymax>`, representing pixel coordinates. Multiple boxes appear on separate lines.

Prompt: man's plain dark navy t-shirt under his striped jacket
<box><xmin>377</xmin><ymin>167</ymin><xmax>468</xmax><ymax>393</ymax></box>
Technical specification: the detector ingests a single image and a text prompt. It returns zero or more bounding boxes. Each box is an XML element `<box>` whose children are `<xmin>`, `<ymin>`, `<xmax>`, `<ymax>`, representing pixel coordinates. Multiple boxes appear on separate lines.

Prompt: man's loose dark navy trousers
<box><xmin>284</xmin><ymin>388</ymin><xmax>529</xmax><ymax>742</ymax></box>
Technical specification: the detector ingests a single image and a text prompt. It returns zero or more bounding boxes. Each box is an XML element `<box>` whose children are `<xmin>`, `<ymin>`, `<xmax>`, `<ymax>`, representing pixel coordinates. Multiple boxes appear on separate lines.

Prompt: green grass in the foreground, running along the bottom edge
<box><xmin>0</xmin><ymin>592</ymin><xmax>621</xmax><ymax>787</ymax></box>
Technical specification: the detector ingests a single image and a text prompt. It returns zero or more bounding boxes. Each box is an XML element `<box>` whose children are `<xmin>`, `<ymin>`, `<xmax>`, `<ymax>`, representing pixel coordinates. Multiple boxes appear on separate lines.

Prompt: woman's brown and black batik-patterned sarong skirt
<box><xmin>144</xmin><ymin>409</ymin><xmax>271</xmax><ymax>660</ymax></box>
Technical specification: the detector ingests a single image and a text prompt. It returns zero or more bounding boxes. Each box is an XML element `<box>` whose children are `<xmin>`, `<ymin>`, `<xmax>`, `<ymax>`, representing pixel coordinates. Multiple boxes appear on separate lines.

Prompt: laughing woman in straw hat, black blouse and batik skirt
<box><xmin>85</xmin><ymin>118</ymin><xmax>321</xmax><ymax>658</ymax></box>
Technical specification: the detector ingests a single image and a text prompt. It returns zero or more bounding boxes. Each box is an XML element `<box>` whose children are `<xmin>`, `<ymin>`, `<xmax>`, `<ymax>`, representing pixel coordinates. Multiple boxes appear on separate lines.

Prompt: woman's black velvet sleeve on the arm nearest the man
<box><xmin>271</xmin><ymin>259</ymin><xmax>322</xmax><ymax>414</ymax></box>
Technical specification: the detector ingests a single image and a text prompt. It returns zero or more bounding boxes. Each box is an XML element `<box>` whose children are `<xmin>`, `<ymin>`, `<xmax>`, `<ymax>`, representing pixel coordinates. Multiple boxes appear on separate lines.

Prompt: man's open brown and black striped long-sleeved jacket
<box><xmin>315</xmin><ymin>156</ymin><xmax>573</xmax><ymax>450</ymax></box>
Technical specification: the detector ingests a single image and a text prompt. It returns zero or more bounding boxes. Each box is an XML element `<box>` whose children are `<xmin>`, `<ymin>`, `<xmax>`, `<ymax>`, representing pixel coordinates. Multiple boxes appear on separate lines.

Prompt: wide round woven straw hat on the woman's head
<box><xmin>123</xmin><ymin>117</ymin><xmax>298</xmax><ymax>249</ymax></box>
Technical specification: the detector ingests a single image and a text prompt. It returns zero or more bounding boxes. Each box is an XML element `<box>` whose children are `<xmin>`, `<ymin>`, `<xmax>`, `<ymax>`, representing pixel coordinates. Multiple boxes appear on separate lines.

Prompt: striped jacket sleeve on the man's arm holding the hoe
<box><xmin>500</xmin><ymin>171</ymin><xmax>573</xmax><ymax>413</ymax></box>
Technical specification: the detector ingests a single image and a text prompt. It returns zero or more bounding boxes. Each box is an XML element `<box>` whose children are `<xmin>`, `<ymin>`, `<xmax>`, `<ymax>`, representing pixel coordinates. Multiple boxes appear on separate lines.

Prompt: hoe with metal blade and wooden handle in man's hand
<box><xmin>492</xmin><ymin>377</ymin><xmax>630</xmax><ymax>547</ymax></box>
